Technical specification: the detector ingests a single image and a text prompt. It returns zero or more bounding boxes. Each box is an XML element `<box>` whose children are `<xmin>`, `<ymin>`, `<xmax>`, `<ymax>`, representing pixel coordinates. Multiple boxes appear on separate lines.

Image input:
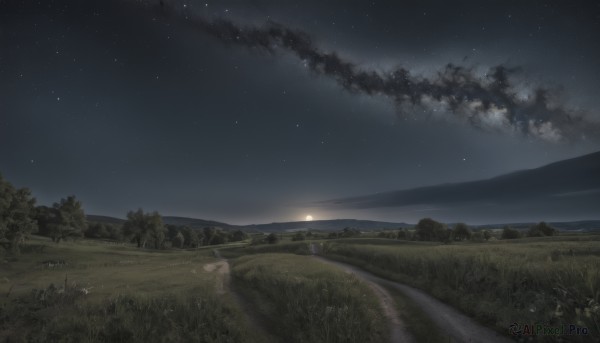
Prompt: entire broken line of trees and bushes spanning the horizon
<box><xmin>0</xmin><ymin>174</ymin><xmax>558</xmax><ymax>253</ymax></box>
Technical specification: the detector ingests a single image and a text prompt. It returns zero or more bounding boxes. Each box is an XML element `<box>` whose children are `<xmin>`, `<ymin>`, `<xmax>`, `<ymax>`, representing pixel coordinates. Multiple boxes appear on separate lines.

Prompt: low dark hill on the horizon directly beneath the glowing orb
<box><xmin>246</xmin><ymin>219</ymin><xmax>411</xmax><ymax>232</ymax></box>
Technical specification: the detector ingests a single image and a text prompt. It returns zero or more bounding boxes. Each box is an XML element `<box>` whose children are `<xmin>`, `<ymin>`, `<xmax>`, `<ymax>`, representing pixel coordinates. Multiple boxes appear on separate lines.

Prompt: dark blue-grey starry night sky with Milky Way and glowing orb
<box><xmin>0</xmin><ymin>0</ymin><xmax>600</xmax><ymax>224</ymax></box>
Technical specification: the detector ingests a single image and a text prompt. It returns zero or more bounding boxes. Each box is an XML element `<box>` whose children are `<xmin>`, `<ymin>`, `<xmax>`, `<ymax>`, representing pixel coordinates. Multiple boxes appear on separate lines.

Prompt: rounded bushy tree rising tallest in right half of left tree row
<box><xmin>123</xmin><ymin>208</ymin><xmax>166</xmax><ymax>249</ymax></box>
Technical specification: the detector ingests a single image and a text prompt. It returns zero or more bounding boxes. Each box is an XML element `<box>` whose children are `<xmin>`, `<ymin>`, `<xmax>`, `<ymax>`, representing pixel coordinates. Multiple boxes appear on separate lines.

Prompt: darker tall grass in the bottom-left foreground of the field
<box><xmin>0</xmin><ymin>286</ymin><xmax>249</xmax><ymax>342</ymax></box>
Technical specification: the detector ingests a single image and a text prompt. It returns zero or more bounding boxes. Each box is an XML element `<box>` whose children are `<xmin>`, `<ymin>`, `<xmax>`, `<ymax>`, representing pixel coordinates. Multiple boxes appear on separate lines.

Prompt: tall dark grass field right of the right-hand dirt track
<box><xmin>323</xmin><ymin>241</ymin><xmax>600</xmax><ymax>337</ymax></box>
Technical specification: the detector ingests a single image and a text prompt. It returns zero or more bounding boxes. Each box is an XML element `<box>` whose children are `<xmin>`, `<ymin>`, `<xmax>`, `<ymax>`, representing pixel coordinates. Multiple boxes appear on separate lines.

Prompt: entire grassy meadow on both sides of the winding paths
<box><xmin>0</xmin><ymin>234</ymin><xmax>600</xmax><ymax>342</ymax></box>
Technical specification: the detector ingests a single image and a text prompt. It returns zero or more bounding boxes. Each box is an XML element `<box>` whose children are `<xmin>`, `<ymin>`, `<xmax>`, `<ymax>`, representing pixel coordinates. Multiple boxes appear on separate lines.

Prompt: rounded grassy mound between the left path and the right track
<box><xmin>232</xmin><ymin>254</ymin><xmax>388</xmax><ymax>343</ymax></box>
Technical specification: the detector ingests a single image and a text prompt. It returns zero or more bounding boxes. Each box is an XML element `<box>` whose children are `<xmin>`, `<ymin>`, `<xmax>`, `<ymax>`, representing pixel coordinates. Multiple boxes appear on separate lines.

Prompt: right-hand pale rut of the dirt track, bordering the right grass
<box><xmin>314</xmin><ymin>256</ymin><xmax>513</xmax><ymax>343</ymax></box>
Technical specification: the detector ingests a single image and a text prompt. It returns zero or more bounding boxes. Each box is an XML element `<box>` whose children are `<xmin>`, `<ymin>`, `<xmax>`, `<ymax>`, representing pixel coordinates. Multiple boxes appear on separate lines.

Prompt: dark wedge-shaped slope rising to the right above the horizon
<box><xmin>318</xmin><ymin>152</ymin><xmax>600</xmax><ymax>213</ymax></box>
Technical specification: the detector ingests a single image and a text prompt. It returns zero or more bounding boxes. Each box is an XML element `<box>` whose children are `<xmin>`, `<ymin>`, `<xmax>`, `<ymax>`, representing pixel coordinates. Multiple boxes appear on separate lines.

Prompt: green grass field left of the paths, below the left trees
<box><xmin>0</xmin><ymin>238</ymin><xmax>260</xmax><ymax>342</ymax></box>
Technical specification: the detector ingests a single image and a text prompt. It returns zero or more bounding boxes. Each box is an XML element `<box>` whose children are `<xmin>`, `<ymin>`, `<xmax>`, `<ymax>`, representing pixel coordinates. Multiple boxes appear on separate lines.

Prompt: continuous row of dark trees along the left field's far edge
<box><xmin>0</xmin><ymin>174</ymin><xmax>248</xmax><ymax>253</ymax></box>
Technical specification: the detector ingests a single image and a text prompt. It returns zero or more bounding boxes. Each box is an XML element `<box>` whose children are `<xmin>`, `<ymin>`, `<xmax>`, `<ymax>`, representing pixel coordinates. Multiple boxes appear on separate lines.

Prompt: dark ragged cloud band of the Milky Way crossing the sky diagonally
<box><xmin>161</xmin><ymin>1</ymin><xmax>600</xmax><ymax>142</ymax></box>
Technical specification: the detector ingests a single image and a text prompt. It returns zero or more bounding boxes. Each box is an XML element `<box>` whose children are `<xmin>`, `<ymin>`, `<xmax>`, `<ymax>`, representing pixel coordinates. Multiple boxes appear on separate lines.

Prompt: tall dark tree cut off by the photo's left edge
<box><xmin>0</xmin><ymin>175</ymin><xmax>37</xmax><ymax>253</ymax></box>
